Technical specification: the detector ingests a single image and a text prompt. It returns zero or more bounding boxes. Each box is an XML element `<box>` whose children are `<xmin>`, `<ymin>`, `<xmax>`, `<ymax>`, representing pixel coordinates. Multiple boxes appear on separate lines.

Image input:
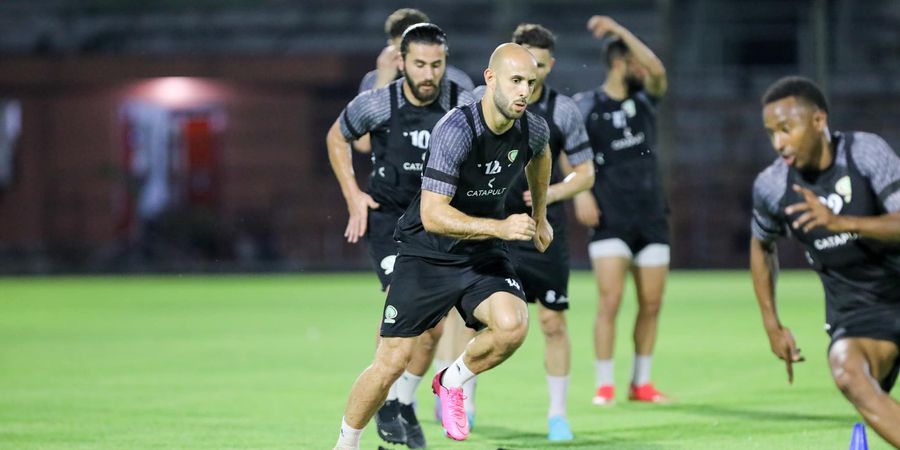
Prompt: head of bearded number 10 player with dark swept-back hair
<box><xmin>400</xmin><ymin>23</ymin><xmax>447</xmax><ymax>102</ymax></box>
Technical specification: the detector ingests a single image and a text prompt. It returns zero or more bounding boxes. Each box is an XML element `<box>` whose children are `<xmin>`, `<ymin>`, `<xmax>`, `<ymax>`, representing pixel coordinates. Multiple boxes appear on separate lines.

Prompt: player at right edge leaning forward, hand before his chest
<box><xmin>750</xmin><ymin>77</ymin><xmax>900</xmax><ymax>448</ymax></box>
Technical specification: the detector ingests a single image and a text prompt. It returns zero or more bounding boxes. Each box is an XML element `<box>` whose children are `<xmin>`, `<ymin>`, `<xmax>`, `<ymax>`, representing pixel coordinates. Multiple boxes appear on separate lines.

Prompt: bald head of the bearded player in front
<box><xmin>484</xmin><ymin>42</ymin><xmax>537</xmax><ymax>119</ymax></box>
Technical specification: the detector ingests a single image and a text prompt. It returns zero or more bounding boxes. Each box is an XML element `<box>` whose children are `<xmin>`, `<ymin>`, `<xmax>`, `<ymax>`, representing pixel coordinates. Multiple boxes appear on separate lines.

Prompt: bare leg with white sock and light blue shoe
<box><xmin>538</xmin><ymin>303</ymin><xmax>573</xmax><ymax>441</ymax></box>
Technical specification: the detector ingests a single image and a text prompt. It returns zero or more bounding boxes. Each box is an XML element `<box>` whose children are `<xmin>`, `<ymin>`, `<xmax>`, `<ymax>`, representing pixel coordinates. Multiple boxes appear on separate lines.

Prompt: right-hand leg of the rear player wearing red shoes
<box><xmin>629</xmin><ymin>244</ymin><xmax>669</xmax><ymax>402</ymax></box>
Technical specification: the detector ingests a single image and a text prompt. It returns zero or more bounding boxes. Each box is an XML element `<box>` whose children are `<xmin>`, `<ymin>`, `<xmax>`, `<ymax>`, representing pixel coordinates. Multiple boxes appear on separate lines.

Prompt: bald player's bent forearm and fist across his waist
<box><xmin>420</xmin><ymin>189</ymin><xmax>535</xmax><ymax>241</ymax></box>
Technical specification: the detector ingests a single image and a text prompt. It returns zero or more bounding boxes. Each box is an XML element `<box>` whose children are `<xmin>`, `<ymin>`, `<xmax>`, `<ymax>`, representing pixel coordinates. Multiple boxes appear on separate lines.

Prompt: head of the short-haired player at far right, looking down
<box><xmin>762</xmin><ymin>76</ymin><xmax>828</xmax><ymax>170</ymax></box>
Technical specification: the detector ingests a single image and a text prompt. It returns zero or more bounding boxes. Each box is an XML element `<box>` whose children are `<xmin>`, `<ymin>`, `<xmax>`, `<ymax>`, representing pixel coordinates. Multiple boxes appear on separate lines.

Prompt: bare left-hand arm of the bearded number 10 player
<box><xmin>325</xmin><ymin>119</ymin><xmax>379</xmax><ymax>243</ymax></box>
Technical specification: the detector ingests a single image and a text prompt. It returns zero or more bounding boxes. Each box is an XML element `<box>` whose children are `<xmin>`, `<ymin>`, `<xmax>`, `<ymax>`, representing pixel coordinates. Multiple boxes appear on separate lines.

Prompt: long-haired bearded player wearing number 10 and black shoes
<box><xmin>327</xmin><ymin>24</ymin><xmax>474</xmax><ymax>448</ymax></box>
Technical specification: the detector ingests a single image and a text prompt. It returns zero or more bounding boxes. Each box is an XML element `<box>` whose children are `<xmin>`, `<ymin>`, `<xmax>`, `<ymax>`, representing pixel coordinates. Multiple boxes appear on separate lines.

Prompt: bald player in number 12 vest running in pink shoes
<box><xmin>336</xmin><ymin>43</ymin><xmax>553</xmax><ymax>449</ymax></box>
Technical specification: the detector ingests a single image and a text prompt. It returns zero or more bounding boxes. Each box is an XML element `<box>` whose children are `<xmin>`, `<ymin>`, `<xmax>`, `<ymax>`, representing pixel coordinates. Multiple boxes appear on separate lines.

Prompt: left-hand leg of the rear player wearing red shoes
<box><xmin>588</xmin><ymin>238</ymin><xmax>631</xmax><ymax>405</ymax></box>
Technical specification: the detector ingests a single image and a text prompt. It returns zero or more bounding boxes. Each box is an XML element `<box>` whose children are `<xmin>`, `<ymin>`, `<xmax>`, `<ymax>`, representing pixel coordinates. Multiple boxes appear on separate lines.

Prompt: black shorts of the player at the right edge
<box><xmin>828</xmin><ymin>307</ymin><xmax>900</xmax><ymax>392</ymax></box>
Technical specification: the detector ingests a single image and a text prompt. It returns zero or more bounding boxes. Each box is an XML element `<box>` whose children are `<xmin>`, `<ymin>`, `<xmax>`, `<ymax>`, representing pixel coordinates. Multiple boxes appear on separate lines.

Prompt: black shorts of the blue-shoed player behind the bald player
<box><xmin>509</xmin><ymin>234</ymin><xmax>569</xmax><ymax>311</ymax></box>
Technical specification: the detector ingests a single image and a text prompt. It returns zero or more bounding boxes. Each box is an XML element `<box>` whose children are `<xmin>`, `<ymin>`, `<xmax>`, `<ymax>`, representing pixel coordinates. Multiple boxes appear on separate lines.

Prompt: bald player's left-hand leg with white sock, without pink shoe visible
<box><xmin>335</xmin><ymin>337</ymin><xmax>415</xmax><ymax>449</ymax></box>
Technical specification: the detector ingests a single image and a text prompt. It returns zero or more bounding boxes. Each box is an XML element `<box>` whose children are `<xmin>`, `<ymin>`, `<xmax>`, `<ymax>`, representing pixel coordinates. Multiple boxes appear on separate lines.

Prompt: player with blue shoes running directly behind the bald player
<box><xmin>474</xmin><ymin>24</ymin><xmax>594</xmax><ymax>441</ymax></box>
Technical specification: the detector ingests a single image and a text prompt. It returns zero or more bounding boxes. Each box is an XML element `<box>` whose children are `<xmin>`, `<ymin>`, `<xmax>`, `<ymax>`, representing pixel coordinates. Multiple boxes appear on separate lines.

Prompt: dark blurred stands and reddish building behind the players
<box><xmin>0</xmin><ymin>0</ymin><xmax>900</xmax><ymax>274</ymax></box>
